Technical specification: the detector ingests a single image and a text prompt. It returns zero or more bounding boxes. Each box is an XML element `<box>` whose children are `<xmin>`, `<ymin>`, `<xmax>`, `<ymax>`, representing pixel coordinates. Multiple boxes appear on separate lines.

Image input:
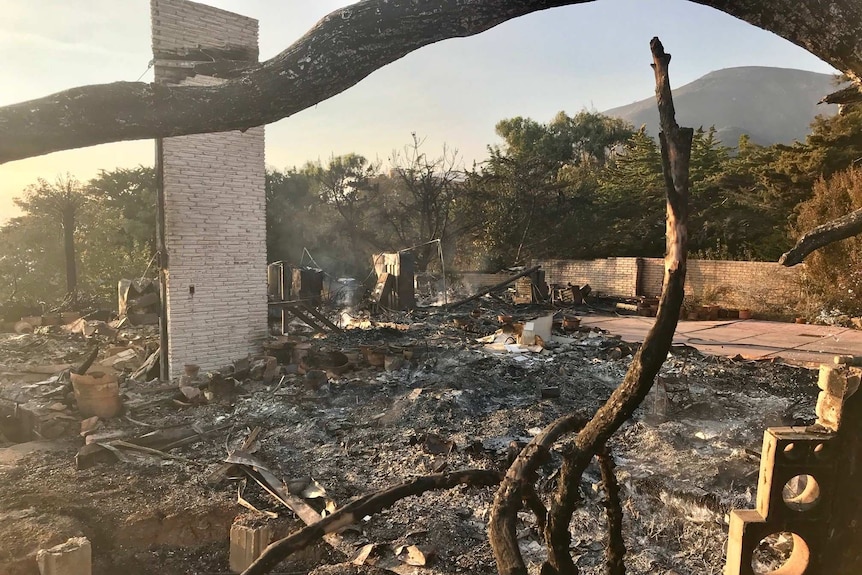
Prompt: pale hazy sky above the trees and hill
<box><xmin>0</xmin><ymin>0</ymin><xmax>834</xmax><ymax>221</ymax></box>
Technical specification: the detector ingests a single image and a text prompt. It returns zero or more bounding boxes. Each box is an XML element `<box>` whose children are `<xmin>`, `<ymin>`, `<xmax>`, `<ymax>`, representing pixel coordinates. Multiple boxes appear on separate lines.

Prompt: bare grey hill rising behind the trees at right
<box><xmin>604</xmin><ymin>66</ymin><xmax>838</xmax><ymax>146</ymax></box>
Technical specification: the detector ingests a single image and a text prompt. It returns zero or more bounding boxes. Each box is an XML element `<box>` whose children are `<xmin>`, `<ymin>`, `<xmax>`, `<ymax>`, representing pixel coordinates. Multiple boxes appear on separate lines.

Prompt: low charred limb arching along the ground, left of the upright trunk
<box><xmin>242</xmin><ymin>469</ymin><xmax>502</xmax><ymax>575</ymax></box>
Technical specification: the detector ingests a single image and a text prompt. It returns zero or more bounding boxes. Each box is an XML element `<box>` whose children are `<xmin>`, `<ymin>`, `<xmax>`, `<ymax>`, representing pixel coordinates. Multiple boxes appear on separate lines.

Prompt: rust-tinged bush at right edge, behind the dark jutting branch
<box><xmin>795</xmin><ymin>168</ymin><xmax>862</xmax><ymax>315</ymax></box>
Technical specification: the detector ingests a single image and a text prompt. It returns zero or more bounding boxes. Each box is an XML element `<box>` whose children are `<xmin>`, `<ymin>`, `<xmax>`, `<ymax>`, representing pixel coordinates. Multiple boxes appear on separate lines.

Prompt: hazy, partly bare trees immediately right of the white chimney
<box><xmin>267</xmin><ymin>135</ymin><xmax>469</xmax><ymax>277</ymax></box>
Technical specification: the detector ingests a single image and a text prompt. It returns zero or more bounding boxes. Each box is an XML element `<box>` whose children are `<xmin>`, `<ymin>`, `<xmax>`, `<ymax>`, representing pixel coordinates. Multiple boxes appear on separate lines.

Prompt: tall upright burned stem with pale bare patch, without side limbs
<box><xmin>544</xmin><ymin>38</ymin><xmax>693</xmax><ymax>575</ymax></box>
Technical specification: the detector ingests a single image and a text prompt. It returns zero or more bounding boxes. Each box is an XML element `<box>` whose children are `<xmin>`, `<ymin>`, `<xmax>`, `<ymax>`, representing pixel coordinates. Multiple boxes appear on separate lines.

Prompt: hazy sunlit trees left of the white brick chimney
<box><xmin>0</xmin><ymin>167</ymin><xmax>155</xmax><ymax>307</ymax></box>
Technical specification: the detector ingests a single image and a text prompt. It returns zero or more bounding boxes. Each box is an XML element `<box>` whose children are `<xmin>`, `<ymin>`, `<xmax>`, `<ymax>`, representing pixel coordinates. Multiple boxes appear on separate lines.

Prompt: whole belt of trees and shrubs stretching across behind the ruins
<box><xmin>5</xmin><ymin>103</ymin><xmax>862</xmax><ymax>308</ymax></box>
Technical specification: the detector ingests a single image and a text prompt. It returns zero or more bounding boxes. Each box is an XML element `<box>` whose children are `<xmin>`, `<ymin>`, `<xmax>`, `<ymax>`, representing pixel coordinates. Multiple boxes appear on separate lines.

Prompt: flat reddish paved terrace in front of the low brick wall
<box><xmin>581</xmin><ymin>315</ymin><xmax>862</xmax><ymax>365</ymax></box>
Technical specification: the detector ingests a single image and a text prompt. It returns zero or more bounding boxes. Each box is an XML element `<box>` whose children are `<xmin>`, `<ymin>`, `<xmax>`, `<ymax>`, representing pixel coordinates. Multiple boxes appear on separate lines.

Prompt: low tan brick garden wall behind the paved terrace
<box><xmin>533</xmin><ymin>258</ymin><xmax>802</xmax><ymax>309</ymax></box>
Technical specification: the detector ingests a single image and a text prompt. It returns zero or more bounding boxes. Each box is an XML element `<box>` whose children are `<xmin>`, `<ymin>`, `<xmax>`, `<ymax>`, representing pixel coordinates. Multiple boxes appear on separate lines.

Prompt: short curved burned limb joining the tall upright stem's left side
<box><xmin>488</xmin><ymin>414</ymin><xmax>586</xmax><ymax>575</ymax></box>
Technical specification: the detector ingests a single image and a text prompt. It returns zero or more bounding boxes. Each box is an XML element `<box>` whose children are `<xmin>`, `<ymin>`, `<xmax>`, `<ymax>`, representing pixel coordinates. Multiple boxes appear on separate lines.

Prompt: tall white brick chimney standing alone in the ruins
<box><xmin>151</xmin><ymin>0</ymin><xmax>267</xmax><ymax>377</ymax></box>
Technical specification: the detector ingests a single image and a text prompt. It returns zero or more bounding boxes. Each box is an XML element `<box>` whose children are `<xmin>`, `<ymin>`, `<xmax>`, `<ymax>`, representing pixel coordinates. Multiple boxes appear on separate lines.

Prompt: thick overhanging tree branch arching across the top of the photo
<box><xmin>0</xmin><ymin>0</ymin><xmax>862</xmax><ymax>163</ymax></box>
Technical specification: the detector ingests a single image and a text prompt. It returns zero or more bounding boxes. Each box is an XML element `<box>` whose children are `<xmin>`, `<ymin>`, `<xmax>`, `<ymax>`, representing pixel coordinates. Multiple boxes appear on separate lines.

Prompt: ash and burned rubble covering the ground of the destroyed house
<box><xmin>0</xmin><ymin>268</ymin><xmax>852</xmax><ymax>573</ymax></box>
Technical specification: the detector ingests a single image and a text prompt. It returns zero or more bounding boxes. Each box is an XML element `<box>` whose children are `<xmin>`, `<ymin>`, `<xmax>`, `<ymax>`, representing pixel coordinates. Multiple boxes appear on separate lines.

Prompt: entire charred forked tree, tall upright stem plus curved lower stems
<box><xmin>489</xmin><ymin>38</ymin><xmax>694</xmax><ymax>575</ymax></box>
